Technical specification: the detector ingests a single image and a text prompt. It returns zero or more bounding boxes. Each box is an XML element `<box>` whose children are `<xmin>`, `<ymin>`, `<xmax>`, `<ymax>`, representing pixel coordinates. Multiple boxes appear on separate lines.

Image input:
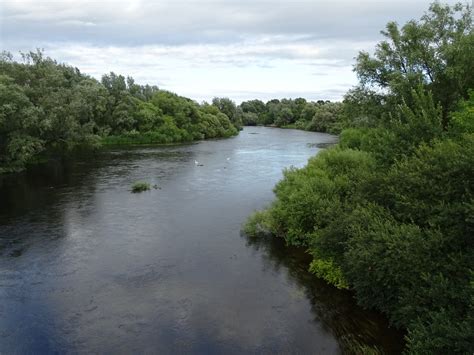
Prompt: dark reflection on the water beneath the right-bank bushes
<box><xmin>241</xmin><ymin>232</ymin><xmax>403</xmax><ymax>354</ymax></box>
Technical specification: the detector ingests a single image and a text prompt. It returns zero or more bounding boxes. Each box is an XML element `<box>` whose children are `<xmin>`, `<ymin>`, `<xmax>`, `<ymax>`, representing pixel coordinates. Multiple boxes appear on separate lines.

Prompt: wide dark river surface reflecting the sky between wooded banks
<box><xmin>0</xmin><ymin>128</ymin><xmax>401</xmax><ymax>354</ymax></box>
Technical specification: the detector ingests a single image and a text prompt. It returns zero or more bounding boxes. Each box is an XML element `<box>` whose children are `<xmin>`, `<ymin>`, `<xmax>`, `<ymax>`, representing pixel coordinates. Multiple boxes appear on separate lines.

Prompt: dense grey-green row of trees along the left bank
<box><xmin>0</xmin><ymin>52</ymin><xmax>240</xmax><ymax>173</ymax></box>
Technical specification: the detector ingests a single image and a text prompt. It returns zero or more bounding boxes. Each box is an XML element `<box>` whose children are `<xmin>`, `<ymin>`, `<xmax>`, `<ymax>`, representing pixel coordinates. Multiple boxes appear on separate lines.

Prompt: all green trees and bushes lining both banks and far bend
<box><xmin>0</xmin><ymin>2</ymin><xmax>474</xmax><ymax>354</ymax></box>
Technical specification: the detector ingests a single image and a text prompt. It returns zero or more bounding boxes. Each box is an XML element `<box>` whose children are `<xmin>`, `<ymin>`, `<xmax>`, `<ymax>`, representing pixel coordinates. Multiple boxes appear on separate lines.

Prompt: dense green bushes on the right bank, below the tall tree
<box><xmin>245</xmin><ymin>96</ymin><xmax>474</xmax><ymax>353</ymax></box>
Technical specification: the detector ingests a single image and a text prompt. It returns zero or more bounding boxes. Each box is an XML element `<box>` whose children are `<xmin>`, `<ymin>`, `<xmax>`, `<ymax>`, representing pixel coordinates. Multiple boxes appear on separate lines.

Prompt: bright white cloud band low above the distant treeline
<box><xmin>32</xmin><ymin>37</ymin><xmax>355</xmax><ymax>101</ymax></box>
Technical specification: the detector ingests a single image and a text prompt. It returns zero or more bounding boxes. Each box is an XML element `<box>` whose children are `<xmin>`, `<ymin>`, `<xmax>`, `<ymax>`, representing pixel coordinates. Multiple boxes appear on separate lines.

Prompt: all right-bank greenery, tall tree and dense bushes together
<box><xmin>246</xmin><ymin>3</ymin><xmax>474</xmax><ymax>354</ymax></box>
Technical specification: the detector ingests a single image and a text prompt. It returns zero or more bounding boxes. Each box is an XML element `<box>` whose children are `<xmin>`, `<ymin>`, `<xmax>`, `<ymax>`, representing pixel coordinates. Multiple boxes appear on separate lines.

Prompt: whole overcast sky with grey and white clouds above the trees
<box><xmin>0</xmin><ymin>0</ymin><xmax>462</xmax><ymax>102</ymax></box>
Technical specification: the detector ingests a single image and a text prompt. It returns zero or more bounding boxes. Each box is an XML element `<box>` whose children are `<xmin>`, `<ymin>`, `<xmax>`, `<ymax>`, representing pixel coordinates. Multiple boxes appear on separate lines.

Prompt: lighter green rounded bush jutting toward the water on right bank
<box><xmin>271</xmin><ymin>148</ymin><xmax>374</xmax><ymax>246</ymax></box>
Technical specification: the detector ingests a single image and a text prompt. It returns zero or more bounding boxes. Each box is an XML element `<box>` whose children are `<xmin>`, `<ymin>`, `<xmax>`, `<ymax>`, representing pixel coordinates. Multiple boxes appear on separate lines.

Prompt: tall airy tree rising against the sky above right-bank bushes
<box><xmin>354</xmin><ymin>2</ymin><xmax>474</xmax><ymax>128</ymax></box>
